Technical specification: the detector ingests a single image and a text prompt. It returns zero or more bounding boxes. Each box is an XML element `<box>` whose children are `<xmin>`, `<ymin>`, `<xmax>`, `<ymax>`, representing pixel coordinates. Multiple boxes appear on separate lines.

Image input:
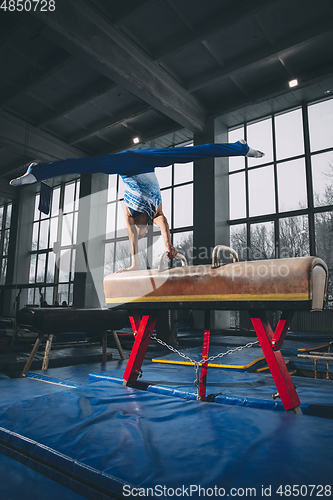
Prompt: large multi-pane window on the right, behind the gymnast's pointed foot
<box><xmin>229</xmin><ymin>99</ymin><xmax>333</xmax><ymax>300</ymax></box>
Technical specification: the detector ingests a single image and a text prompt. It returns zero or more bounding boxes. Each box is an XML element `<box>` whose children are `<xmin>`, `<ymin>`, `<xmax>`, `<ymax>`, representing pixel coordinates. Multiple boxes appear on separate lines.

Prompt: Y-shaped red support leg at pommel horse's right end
<box><xmin>250</xmin><ymin>312</ymin><xmax>302</xmax><ymax>413</ymax></box>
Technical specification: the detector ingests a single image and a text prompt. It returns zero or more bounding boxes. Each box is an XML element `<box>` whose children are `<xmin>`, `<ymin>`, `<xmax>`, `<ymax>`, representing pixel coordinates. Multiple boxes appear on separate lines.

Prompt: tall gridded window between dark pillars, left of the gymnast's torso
<box><xmin>28</xmin><ymin>180</ymin><xmax>80</xmax><ymax>305</ymax></box>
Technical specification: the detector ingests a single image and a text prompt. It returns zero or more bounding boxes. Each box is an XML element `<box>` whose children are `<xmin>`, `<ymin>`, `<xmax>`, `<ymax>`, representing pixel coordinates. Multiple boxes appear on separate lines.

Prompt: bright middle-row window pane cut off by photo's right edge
<box><xmin>311</xmin><ymin>151</ymin><xmax>333</xmax><ymax>207</ymax></box>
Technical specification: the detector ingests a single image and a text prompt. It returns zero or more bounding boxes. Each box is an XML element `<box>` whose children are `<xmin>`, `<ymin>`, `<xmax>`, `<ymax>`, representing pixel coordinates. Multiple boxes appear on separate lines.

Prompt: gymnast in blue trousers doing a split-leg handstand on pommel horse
<box><xmin>10</xmin><ymin>140</ymin><xmax>264</xmax><ymax>272</ymax></box>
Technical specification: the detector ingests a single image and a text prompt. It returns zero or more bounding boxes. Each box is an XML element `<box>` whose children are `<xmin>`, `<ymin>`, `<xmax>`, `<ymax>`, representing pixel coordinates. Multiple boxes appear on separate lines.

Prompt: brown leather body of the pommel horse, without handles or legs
<box><xmin>104</xmin><ymin>257</ymin><xmax>328</xmax><ymax>311</ymax></box>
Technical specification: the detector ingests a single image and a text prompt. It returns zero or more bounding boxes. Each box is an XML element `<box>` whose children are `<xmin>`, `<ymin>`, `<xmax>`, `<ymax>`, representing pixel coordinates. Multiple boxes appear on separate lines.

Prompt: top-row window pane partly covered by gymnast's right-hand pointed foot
<box><xmin>247</xmin><ymin>118</ymin><xmax>273</xmax><ymax>166</ymax></box>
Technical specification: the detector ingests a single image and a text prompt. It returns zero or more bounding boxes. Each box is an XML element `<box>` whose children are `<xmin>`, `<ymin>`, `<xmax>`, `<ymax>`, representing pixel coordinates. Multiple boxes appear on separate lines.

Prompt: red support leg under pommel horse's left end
<box><xmin>123</xmin><ymin>314</ymin><xmax>157</xmax><ymax>385</ymax></box>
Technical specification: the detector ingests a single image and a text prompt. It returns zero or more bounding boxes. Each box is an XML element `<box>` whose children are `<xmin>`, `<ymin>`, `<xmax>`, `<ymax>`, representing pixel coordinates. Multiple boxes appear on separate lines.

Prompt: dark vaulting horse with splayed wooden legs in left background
<box><xmin>18</xmin><ymin>307</ymin><xmax>128</xmax><ymax>376</ymax></box>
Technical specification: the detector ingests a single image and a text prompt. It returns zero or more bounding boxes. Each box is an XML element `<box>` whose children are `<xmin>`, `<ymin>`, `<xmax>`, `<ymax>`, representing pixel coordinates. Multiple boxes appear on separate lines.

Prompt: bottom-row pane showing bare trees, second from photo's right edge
<box><xmin>279</xmin><ymin>215</ymin><xmax>310</xmax><ymax>258</ymax></box>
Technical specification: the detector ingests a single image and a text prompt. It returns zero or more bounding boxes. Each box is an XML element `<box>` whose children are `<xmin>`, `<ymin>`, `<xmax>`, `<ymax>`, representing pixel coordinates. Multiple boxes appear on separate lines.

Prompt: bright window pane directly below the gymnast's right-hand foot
<box><xmin>249</xmin><ymin>166</ymin><xmax>275</xmax><ymax>217</ymax></box>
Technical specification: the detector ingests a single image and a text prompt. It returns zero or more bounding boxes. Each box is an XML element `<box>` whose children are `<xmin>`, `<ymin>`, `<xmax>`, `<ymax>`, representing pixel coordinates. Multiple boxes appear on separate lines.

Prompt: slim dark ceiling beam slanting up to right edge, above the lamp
<box><xmin>186</xmin><ymin>21</ymin><xmax>333</xmax><ymax>92</ymax></box>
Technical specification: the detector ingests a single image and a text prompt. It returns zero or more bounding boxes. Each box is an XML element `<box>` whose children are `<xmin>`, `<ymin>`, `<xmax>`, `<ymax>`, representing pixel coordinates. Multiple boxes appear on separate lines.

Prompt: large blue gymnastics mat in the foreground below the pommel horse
<box><xmin>0</xmin><ymin>373</ymin><xmax>333</xmax><ymax>500</ymax></box>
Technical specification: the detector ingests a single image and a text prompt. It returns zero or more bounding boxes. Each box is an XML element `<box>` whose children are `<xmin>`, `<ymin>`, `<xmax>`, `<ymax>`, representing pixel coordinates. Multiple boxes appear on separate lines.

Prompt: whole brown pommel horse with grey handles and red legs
<box><xmin>104</xmin><ymin>245</ymin><xmax>328</xmax><ymax>413</ymax></box>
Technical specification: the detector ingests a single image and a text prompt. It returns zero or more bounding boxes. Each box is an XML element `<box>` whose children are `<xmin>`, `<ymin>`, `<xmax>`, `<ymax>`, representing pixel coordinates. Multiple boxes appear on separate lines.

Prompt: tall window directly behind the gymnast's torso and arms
<box><xmin>105</xmin><ymin>148</ymin><xmax>193</xmax><ymax>274</ymax></box>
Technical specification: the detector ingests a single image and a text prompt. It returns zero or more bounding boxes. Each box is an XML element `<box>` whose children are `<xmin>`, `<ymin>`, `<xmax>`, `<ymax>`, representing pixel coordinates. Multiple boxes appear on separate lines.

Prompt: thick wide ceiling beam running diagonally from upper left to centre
<box><xmin>27</xmin><ymin>0</ymin><xmax>206</xmax><ymax>133</ymax></box>
